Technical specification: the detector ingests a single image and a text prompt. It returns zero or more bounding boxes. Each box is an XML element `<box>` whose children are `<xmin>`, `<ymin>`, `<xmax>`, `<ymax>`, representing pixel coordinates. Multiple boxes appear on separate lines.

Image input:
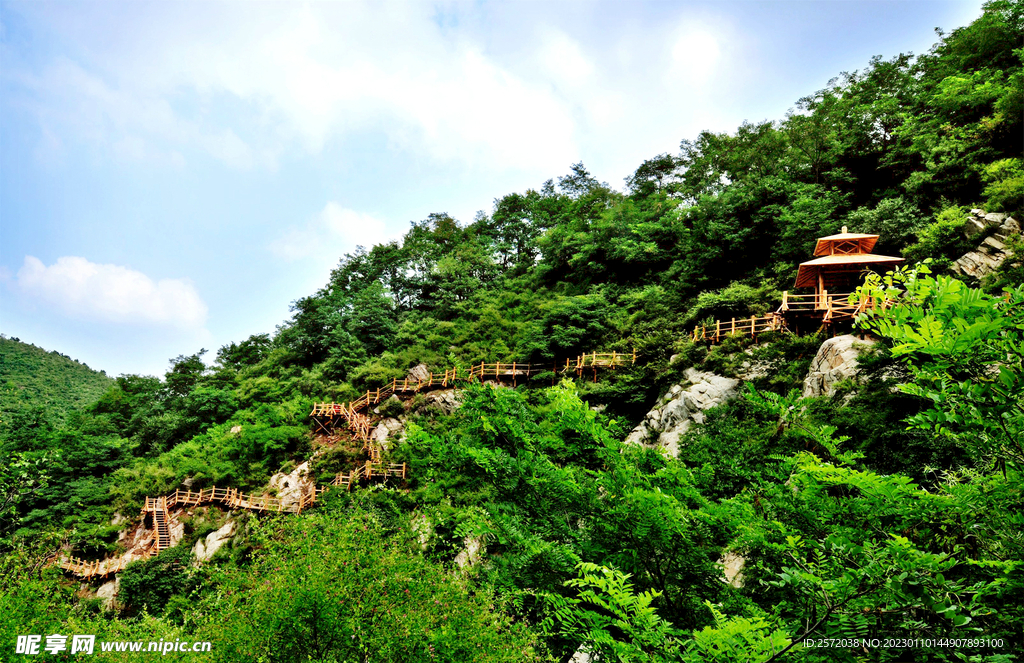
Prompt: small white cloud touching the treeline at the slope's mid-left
<box><xmin>268</xmin><ymin>201</ymin><xmax>389</xmax><ymax>261</ymax></box>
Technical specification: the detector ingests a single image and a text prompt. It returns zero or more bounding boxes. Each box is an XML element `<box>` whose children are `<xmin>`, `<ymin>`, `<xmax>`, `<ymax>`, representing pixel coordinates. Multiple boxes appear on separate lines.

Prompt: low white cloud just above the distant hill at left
<box><xmin>15</xmin><ymin>255</ymin><xmax>207</xmax><ymax>330</ymax></box>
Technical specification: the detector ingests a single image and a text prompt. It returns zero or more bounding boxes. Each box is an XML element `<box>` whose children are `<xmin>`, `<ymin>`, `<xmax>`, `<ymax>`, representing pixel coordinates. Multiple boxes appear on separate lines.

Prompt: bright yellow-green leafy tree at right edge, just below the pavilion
<box><xmin>858</xmin><ymin>264</ymin><xmax>1024</xmax><ymax>466</ymax></box>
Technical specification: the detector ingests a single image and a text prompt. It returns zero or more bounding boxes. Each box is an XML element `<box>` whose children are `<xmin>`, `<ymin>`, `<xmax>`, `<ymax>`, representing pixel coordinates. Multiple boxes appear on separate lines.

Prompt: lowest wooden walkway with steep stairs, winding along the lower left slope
<box><xmin>53</xmin><ymin>460</ymin><xmax>408</xmax><ymax>578</ymax></box>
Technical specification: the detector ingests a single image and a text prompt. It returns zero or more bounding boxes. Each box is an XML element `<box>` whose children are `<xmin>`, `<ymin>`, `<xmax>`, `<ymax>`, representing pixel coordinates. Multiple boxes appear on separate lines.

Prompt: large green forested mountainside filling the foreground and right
<box><xmin>0</xmin><ymin>0</ymin><xmax>1024</xmax><ymax>663</ymax></box>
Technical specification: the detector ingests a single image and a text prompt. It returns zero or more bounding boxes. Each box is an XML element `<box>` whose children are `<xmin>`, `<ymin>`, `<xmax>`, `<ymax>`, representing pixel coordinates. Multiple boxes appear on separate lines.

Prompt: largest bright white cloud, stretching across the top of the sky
<box><xmin>12</xmin><ymin>2</ymin><xmax>586</xmax><ymax>168</ymax></box>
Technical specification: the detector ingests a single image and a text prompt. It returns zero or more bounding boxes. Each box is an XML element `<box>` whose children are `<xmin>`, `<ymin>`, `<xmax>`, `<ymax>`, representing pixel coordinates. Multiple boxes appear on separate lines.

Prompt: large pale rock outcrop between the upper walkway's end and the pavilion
<box><xmin>626</xmin><ymin>368</ymin><xmax>739</xmax><ymax>457</ymax></box>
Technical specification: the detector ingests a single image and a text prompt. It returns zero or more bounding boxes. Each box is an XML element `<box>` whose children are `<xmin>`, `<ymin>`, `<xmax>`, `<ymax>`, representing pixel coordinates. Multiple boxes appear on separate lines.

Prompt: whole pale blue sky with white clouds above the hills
<box><xmin>0</xmin><ymin>0</ymin><xmax>981</xmax><ymax>375</ymax></box>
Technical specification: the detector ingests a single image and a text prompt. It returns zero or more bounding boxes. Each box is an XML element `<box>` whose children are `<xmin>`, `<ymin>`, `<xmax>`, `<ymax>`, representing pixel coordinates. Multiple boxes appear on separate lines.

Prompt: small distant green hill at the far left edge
<box><xmin>0</xmin><ymin>337</ymin><xmax>114</xmax><ymax>425</ymax></box>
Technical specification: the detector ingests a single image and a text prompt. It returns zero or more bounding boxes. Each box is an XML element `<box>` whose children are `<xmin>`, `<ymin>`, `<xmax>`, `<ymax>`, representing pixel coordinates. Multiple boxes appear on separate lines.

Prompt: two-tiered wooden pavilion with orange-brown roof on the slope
<box><xmin>777</xmin><ymin>225</ymin><xmax>903</xmax><ymax>329</ymax></box>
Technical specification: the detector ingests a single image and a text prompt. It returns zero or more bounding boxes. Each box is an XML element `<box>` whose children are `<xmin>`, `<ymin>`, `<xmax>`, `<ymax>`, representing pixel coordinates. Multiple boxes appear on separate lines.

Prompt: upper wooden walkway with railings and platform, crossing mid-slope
<box><xmin>309</xmin><ymin>350</ymin><xmax>637</xmax><ymax>446</ymax></box>
